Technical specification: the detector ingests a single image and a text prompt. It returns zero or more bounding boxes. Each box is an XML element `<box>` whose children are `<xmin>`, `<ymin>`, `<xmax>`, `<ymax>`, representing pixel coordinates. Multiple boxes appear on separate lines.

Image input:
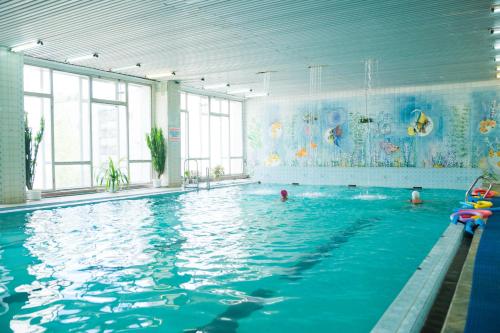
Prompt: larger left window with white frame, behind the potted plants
<box><xmin>24</xmin><ymin>65</ymin><xmax>151</xmax><ymax>190</ymax></box>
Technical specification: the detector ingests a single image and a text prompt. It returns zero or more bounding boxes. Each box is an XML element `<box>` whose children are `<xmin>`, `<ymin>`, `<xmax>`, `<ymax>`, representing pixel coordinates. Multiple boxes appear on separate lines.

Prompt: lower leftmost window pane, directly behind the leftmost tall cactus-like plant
<box><xmin>24</xmin><ymin>96</ymin><xmax>52</xmax><ymax>190</ymax></box>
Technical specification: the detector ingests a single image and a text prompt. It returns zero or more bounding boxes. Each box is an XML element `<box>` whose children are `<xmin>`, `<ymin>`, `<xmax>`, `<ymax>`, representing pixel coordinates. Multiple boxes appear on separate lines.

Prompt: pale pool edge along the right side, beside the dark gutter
<box><xmin>372</xmin><ymin>220</ymin><xmax>463</xmax><ymax>333</ymax></box>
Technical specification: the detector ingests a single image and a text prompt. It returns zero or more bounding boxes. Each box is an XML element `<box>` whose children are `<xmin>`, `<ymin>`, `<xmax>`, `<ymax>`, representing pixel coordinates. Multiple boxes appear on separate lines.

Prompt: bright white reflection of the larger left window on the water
<box><xmin>12</xmin><ymin>200</ymin><xmax>162</xmax><ymax>331</ymax></box>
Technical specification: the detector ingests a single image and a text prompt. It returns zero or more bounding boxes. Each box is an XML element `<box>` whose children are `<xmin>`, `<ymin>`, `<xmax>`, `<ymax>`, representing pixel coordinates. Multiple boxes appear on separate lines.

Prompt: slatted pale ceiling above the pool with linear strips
<box><xmin>0</xmin><ymin>0</ymin><xmax>500</xmax><ymax>95</ymax></box>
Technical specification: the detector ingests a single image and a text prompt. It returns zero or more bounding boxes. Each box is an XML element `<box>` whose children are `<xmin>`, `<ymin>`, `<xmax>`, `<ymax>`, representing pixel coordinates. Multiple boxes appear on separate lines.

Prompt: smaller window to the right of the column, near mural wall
<box><xmin>181</xmin><ymin>92</ymin><xmax>244</xmax><ymax>176</ymax></box>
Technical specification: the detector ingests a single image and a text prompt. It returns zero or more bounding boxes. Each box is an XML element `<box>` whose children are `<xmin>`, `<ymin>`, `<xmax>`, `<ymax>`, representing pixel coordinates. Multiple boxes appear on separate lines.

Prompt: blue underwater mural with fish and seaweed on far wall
<box><xmin>247</xmin><ymin>87</ymin><xmax>500</xmax><ymax>180</ymax></box>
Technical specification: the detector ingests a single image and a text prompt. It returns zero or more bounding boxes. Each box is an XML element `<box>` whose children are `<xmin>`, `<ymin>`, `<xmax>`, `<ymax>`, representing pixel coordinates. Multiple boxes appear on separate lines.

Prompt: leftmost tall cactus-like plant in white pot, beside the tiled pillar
<box><xmin>24</xmin><ymin>114</ymin><xmax>45</xmax><ymax>200</ymax></box>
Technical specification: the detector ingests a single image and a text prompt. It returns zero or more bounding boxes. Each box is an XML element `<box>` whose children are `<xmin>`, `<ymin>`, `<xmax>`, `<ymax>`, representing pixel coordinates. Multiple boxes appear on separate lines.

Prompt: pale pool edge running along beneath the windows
<box><xmin>0</xmin><ymin>179</ymin><xmax>257</xmax><ymax>215</ymax></box>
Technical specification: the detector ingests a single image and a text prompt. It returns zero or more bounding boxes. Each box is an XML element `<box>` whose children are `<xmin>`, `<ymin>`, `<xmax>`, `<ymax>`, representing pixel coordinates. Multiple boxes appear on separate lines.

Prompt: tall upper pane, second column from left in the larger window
<box><xmin>54</xmin><ymin>72</ymin><xmax>90</xmax><ymax>162</ymax></box>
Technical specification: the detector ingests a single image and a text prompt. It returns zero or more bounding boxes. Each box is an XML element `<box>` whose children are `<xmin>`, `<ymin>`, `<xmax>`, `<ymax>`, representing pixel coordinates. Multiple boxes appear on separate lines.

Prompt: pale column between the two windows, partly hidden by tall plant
<box><xmin>154</xmin><ymin>81</ymin><xmax>182</xmax><ymax>187</ymax></box>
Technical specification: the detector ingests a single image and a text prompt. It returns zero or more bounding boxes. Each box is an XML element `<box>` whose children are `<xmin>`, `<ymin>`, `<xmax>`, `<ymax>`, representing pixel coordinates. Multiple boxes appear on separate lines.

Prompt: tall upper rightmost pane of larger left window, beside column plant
<box><xmin>128</xmin><ymin>84</ymin><xmax>151</xmax><ymax>160</ymax></box>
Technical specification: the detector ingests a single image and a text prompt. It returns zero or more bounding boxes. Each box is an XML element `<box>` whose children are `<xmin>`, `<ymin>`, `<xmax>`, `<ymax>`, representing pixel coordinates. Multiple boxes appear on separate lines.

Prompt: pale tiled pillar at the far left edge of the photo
<box><xmin>0</xmin><ymin>47</ymin><xmax>26</xmax><ymax>204</ymax></box>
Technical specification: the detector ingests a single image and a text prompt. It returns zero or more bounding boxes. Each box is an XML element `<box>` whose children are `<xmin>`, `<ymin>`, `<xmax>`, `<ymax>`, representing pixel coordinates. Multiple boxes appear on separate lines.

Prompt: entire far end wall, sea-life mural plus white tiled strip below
<box><xmin>246</xmin><ymin>81</ymin><xmax>500</xmax><ymax>188</ymax></box>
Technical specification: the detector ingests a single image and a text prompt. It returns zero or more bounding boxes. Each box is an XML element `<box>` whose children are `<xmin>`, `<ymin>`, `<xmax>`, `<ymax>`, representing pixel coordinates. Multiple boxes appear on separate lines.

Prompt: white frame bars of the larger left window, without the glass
<box><xmin>23</xmin><ymin>63</ymin><xmax>154</xmax><ymax>193</ymax></box>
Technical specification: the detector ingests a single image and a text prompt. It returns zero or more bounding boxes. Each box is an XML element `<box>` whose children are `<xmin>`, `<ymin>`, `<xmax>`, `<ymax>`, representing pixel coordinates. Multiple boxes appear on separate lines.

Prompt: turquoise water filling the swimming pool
<box><xmin>0</xmin><ymin>185</ymin><xmax>463</xmax><ymax>333</ymax></box>
